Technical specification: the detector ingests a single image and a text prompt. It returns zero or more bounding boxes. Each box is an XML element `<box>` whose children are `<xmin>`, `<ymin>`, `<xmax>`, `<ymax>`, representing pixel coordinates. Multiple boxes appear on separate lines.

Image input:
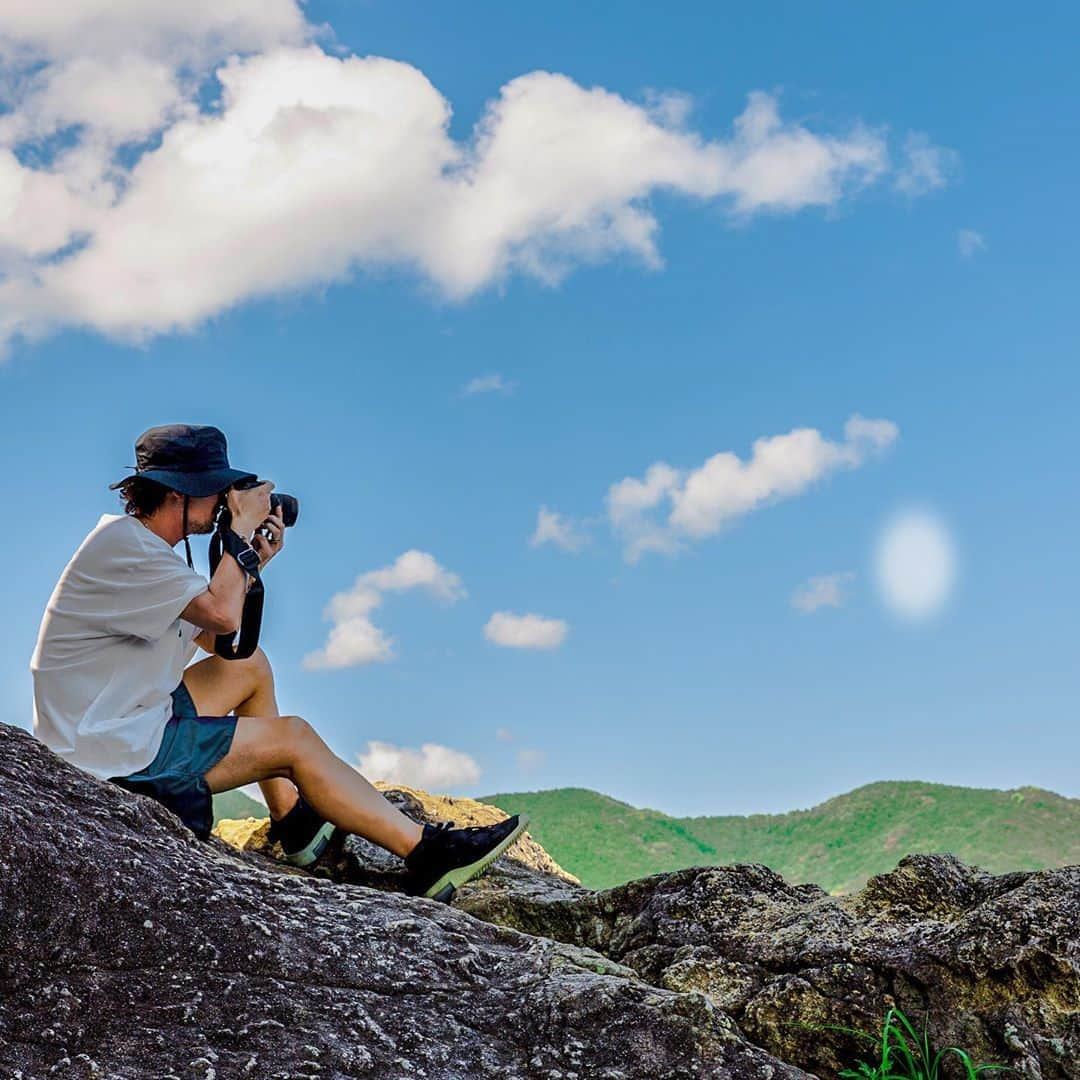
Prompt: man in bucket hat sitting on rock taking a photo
<box><xmin>30</xmin><ymin>424</ymin><xmax>528</xmax><ymax>903</ymax></box>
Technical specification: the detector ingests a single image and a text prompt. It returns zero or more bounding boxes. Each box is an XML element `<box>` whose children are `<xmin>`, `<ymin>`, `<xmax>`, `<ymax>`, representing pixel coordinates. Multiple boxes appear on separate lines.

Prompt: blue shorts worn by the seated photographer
<box><xmin>109</xmin><ymin>679</ymin><xmax>237</xmax><ymax>840</ymax></box>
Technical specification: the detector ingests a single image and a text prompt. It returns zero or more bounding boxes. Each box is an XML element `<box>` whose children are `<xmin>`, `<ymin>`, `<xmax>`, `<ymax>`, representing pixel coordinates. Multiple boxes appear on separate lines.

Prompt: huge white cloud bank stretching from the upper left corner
<box><xmin>0</xmin><ymin>0</ymin><xmax>950</xmax><ymax>358</ymax></box>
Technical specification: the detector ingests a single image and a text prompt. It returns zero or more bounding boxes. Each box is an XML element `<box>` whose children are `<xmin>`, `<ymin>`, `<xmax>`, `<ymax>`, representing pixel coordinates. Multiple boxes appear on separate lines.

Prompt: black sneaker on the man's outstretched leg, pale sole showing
<box><xmin>405</xmin><ymin>813</ymin><xmax>529</xmax><ymax>904</ymax></box>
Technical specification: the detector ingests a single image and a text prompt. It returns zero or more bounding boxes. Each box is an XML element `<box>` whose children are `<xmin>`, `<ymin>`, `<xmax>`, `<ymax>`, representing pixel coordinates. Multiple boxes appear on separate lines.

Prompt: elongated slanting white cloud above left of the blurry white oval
<box><xmin>606</xmin><ymin>414</ymin><xmax>900</xmax><ymax>563</ymax></box>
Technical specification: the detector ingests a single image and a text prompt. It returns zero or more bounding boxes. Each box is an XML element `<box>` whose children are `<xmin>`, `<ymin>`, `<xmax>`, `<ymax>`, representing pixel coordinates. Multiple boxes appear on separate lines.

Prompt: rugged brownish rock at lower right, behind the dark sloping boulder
<box><xmin>212</xmin><ymin>785</ymin><xmax>1080</xmax><ymax>1080</ymax></box>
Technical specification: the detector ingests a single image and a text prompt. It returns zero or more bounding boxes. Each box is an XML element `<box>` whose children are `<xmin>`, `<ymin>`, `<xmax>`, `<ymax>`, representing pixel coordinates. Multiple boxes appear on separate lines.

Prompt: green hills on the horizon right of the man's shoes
<box><xmin>481</xmin><ymin>780</ymin><xmax>1080</xmax><ymax>894</ymax></box>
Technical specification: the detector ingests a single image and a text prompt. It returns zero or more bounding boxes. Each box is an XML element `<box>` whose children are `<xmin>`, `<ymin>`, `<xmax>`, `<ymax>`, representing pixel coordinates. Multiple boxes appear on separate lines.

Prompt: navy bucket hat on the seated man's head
<box><xmin>109</xmin><ymin>423</ymin><xmax>258</xmax><ymax>497</ymax></box>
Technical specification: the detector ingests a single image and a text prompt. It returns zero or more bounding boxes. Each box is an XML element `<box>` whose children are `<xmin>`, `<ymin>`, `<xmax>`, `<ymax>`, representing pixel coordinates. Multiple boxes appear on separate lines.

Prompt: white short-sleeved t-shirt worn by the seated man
<box><xmin>30</xmin><ymin>514</ymin><xmax>210</xmax><ymax>780</ymax></box>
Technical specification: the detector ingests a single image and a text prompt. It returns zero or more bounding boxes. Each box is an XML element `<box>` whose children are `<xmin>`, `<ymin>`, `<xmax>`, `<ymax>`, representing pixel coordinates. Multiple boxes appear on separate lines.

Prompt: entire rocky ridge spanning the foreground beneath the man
<box><xmin>0</xmin><ymin>724</ymin><xmax>1080</xmax><ymax>1080</ymax></box>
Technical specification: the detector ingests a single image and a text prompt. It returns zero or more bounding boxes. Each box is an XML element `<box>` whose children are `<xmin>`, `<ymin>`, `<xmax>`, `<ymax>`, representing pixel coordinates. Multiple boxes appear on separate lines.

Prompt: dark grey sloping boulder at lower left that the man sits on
<box><xmin>0</xmin><ymin>724</ymin><xmax>808</xmax><ymax>1080</ymax></box>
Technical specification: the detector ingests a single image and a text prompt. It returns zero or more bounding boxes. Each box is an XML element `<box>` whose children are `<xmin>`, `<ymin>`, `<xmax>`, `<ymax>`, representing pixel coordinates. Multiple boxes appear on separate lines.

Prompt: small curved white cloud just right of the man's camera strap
<box><xmin>301</xmin><ymin>550</ymin><xmax>468</xmax><ymax>671</ymax></box>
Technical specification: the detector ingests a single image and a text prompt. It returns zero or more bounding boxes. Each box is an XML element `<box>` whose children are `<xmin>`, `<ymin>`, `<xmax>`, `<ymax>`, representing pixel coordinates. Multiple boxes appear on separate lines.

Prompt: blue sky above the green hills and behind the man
<box><xmin>0</xmin><ymin>0</ymin><xmax>1080</xmax><ymax>814</ymax></box>
